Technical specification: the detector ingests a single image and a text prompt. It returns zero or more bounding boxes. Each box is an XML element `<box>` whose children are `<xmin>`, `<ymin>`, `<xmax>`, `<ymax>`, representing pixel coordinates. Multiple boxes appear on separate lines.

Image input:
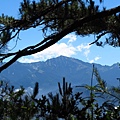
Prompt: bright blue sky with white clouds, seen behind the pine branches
<box><xmin>0</xmin><ymin>0</ymin><xmax>120</xmax><ymax>65</ymax></box>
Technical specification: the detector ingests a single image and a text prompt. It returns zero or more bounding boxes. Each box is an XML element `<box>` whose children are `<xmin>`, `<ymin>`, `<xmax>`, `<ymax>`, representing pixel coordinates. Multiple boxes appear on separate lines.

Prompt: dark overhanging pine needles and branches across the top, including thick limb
<box><xmin>0</xmin><ymin>0</ymin><xmax>120</xmax><ymax>72</ymax></box>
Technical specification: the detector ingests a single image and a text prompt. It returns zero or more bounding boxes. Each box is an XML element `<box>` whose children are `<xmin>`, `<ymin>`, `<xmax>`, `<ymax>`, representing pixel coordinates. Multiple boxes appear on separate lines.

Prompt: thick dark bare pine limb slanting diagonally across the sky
<box><xmin>0</xmin><ymin>6</ymin><xmax>120</xmax><ymax>72</ymax></box>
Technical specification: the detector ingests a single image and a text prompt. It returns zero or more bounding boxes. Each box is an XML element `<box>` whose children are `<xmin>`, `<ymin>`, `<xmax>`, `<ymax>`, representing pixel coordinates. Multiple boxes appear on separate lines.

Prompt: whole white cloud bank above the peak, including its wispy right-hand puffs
<box><xmin>19</xmin><ymin>34</ymin><xmax>96</xmax><ymax>63</ymax></box>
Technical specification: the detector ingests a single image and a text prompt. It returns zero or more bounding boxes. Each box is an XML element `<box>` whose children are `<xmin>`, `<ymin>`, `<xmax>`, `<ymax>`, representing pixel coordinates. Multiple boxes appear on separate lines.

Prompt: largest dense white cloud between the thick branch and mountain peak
<box><xmin>19</xmin><ymin>43</ymin><xmax>76</xmax><ymax>63</ymax></box>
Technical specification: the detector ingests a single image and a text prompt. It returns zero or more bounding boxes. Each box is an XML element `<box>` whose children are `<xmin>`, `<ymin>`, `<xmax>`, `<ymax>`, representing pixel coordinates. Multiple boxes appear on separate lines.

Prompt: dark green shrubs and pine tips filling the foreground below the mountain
<box><xmin>0</xmin><ymin>68</ymin><xmax>120</xmax><ymax>120</ymax></box>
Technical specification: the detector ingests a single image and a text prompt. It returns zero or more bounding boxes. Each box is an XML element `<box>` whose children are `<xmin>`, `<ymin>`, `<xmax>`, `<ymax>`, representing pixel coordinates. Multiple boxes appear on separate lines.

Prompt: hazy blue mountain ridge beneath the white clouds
<box><xmin>0</xmin><ymin>56</ymin><xmax>120</xmax><ymax>94</ymax></box>
